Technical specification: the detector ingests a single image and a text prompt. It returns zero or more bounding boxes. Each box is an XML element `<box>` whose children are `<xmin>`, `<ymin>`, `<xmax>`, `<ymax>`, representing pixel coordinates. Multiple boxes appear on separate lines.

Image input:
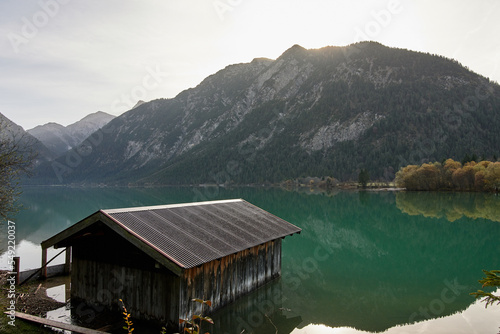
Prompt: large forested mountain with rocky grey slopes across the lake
<box><xmin>33</xmin><ymin>42</ymin><xmax>500</xmax><ymax>184</ymax></box>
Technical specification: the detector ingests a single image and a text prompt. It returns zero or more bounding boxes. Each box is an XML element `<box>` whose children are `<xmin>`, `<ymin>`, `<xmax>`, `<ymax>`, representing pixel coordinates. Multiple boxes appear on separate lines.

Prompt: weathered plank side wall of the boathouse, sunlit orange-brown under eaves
<box><xmin>179</xmin><ymin>239</ymin><xmax>281</xmax><ymax>319</ymax></box>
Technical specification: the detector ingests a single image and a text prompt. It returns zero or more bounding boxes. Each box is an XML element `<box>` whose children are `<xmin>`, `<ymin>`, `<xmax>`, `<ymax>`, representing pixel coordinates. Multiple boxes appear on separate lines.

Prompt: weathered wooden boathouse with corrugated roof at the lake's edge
<box><xmin>42</xmin><ymin>199</ymin><xmax>301</xmax><ymax>328</ymax></box>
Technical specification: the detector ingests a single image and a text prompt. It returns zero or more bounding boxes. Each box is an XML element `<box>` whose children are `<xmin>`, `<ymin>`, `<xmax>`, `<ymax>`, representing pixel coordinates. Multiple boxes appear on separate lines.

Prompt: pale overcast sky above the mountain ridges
<box><xmin>0</xmin><ymin>0</ymin><xmax>500</xmax><ymax>129</ymax></box>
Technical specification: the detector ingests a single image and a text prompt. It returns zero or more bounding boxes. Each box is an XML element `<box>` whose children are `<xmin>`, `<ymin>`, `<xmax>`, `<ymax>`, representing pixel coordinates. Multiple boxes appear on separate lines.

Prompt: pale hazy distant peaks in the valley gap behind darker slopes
<box><xmin>28</xmin><ymin>111</ymin><xmax>115</xmax><ymax>155</ymax></box>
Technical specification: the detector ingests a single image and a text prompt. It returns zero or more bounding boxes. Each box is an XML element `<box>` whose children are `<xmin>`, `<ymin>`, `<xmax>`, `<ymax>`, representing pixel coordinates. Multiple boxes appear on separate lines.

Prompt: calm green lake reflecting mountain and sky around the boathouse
<box><xmin>0</xmin><ymin>187</ymin><xmax>500</xmax><ymax>334</ymax></box>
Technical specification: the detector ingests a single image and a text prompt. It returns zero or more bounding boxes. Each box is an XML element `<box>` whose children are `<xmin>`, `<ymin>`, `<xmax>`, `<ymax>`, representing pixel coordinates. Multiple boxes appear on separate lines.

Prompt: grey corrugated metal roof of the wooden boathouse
<box><xmin>101</xmin><ymin>199</ymin><xmax>301</xmax><ymax>268</ymax></box>
